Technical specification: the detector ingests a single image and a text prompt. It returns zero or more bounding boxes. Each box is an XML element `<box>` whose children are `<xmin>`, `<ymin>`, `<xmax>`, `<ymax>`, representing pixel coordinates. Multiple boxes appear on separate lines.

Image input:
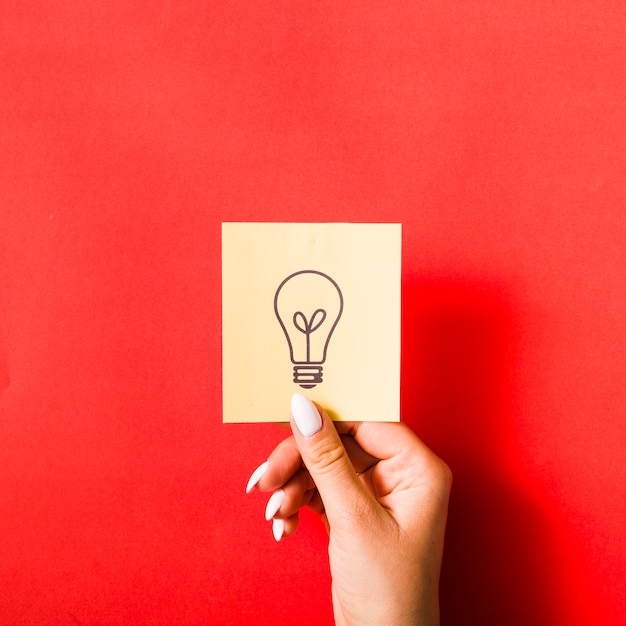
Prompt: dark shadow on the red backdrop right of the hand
<box><xmin>402</xmin><ymin>280</ymin><xmax>559</xmax><ymax>626</ymax></box>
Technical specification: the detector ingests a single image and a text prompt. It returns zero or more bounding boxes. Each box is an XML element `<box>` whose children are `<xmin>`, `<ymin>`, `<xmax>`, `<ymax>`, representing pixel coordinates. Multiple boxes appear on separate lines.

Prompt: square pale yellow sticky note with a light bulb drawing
<box><xmin>222</xmin><ymin>222</ymin><xmax>402</xmax><ymax>422</ymax></box>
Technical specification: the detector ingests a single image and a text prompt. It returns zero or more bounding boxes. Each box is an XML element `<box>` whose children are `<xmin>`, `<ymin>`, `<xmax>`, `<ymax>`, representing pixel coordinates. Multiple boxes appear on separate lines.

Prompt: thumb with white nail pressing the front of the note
<box><xmin>291</xmin><ymin>393</ymin><xmax>375</xmax><ymax>530</ymax></box>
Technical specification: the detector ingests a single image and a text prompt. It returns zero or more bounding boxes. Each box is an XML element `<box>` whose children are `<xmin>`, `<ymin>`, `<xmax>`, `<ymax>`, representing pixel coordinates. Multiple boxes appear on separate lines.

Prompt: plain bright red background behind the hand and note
<box><xmin>0</xmin><ymin>0</ymin><xmax>626</xmax><ymax>626</ymax></box>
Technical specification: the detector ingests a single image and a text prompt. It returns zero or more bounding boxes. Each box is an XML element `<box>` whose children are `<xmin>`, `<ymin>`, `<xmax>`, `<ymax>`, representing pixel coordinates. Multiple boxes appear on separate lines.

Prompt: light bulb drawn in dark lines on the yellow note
<box><xmin>274</xmin><ymin>270</ymin><xmax>343</xmax><ymax>389</ymax></box>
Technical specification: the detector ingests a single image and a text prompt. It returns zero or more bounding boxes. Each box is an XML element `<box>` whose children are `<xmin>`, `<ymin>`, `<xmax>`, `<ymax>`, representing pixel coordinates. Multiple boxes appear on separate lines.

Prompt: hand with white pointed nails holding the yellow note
<box><xmin>247</xmin><ymin>394</ymin><xmax>452</xmax><ymax>626</ymax></box>
